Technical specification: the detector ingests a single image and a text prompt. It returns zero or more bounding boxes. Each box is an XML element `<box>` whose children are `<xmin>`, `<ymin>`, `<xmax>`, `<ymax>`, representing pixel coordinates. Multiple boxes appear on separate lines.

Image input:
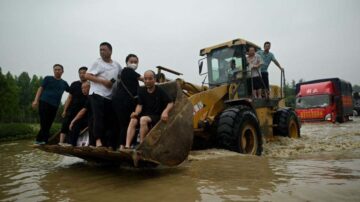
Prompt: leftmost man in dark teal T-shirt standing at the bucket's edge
<box><xmin>32</xmin><ymin>64</ymin><xmax>69</xmax><ymax>145</ymax></box>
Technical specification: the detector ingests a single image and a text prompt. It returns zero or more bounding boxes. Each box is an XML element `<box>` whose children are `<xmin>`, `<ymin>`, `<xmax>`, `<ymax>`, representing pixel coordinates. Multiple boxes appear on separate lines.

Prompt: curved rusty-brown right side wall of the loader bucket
<box><xmin>134</xmin><ymin>81</ymin><xmax>193</xmax><ymax>166</ymax></box>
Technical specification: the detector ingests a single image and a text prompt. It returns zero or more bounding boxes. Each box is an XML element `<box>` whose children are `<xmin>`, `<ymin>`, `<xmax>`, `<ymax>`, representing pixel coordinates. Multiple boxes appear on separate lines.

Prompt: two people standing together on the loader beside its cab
<box><xmin>246</xmin><ymin>41</ymin><xmax>284</xmax><ymax>98</ymax></box>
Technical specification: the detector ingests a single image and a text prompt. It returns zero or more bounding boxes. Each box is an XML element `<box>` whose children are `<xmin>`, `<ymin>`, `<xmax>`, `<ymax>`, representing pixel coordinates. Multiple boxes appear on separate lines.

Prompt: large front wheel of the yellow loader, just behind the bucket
<box><xmin>217</xmin><ymin>106</ymin><xmax>262</xmax><ymax>155</ymax></box>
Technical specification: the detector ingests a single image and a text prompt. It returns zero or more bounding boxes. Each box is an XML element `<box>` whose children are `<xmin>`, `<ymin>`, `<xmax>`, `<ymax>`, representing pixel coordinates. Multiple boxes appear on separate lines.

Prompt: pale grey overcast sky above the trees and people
<box><xmin>0</xmin><ymin>0</ymin><xmax>360</xmax><ymax>87</ymax></box>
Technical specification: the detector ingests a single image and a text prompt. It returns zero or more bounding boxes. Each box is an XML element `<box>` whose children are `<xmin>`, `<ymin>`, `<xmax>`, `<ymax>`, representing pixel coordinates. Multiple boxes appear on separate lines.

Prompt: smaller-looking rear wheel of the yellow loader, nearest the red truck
<box><xmin>273</xmin><ymin>108</ymin><xmax>300</xmax><ymax>138</ymax></box>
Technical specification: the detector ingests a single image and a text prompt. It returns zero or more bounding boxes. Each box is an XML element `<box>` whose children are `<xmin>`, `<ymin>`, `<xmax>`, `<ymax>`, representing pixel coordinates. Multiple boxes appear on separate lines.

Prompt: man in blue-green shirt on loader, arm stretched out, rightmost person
<box><xmin>256</xmin><ymin>41</ymin><xmax>284</xmax><ymax>98</ymax></box>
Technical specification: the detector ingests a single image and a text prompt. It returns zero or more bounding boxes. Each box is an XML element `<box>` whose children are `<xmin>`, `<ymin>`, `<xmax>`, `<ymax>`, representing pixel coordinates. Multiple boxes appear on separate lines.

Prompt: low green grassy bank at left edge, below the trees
<box><xmin>0</xmin><ymin>123</ymin><xmax>61</xmax><ymax>142</ymax></box>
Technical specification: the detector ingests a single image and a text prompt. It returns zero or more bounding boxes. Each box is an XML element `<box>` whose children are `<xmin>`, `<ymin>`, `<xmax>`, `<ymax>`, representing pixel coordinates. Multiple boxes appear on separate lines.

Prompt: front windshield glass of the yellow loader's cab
<box><xmin>207</xmin><ymin>47</ymin><xmax>243</xmax><ymax>86</ymax></box>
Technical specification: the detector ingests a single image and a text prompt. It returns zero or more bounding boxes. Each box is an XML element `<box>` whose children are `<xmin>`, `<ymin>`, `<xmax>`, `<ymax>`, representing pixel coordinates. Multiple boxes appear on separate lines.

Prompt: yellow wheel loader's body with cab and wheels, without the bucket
<box><xmin>169</xmin><ymin>39</ymin><xmax>300</xmax><ymax>155</ymax></box>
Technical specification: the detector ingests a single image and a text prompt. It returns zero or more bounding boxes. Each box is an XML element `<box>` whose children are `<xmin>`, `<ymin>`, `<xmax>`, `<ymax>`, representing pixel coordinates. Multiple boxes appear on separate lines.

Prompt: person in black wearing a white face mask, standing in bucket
<box><xmin>112</xmin><ymin>54</ymin><xmax>143</xmax><ymax>148</ymax></box>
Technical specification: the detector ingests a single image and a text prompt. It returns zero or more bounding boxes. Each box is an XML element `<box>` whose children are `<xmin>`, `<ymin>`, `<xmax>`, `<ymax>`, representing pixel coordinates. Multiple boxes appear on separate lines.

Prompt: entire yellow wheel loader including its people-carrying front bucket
<box><xmin>36</xmin><ymin>39</ymin><xmax>300</xmax><ymax>166</ymax></box>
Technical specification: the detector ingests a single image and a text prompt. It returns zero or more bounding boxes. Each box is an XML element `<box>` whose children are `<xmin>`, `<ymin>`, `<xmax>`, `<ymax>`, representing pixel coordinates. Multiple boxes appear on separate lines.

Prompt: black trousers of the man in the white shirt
<box><xmin>89</xmin><ymin>94</ymin><xmax>116</xmax><ymax>147</ymax></box>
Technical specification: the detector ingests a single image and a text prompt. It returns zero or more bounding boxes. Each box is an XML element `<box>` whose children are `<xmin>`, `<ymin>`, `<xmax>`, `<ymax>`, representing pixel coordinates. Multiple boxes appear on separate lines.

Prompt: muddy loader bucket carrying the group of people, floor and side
<box><xmin>33</xmin><ymin>81</ymin><xmax>193</xmax><ymax>167</ymax></box>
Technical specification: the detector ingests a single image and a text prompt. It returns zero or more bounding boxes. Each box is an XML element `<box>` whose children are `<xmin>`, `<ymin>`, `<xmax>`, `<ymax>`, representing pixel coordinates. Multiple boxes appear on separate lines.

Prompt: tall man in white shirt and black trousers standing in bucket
<box><xmin>85</xmin><ymin>42</ymin><xmax>121</xmax><ymax>147</ymax></box>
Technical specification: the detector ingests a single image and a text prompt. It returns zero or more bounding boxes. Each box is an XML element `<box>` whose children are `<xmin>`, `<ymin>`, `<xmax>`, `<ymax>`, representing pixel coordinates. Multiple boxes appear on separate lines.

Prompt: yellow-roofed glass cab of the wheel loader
<box><xmin>199</xmin><ymin>39</ymin><xmax>260</xmax><ymax>100</ymax></box>
